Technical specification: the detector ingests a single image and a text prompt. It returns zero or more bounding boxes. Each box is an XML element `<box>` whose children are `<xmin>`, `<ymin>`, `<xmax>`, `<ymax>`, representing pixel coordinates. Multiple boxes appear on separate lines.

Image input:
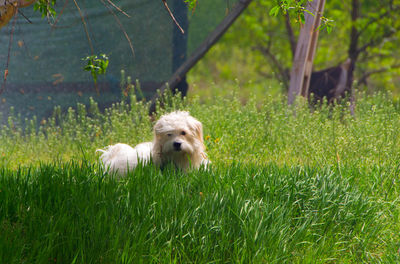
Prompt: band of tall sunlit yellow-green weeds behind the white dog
<box><xmin>0</xmin><ymin>89</ymin><xmax>400</xmax><ymax>168</ymax></box>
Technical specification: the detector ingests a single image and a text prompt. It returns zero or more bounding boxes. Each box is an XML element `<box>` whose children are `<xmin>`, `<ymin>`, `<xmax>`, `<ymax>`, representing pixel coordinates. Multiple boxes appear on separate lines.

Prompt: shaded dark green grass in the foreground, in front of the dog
<box><xmin>0</xmin><ymin>162</ymin><xmax>399</xmax><ymax>263</ymax></box>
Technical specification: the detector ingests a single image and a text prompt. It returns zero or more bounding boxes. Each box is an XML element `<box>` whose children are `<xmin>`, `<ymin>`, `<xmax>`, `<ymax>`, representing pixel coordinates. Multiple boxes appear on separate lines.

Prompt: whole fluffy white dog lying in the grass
<box><xmin>97</xmin><ymin>111</ymin><xmax>209</xmax><ymax>175</ymax></box>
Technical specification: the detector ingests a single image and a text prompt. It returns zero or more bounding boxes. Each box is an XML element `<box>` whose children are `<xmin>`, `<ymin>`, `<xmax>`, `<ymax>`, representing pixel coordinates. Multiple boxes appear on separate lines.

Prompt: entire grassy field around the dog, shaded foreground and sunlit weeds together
<box><xmin>0</xmin><ymin>89</ymin><xmax>400</xmax><ymax>263</ymax></box>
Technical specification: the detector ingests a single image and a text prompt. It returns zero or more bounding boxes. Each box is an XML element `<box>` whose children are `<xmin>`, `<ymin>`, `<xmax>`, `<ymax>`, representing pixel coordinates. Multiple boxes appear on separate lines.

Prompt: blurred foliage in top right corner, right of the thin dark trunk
<box><xmin>346</xmin><ymin>0</ymin><xmax>400</xmax><ymax>90</ymax></box>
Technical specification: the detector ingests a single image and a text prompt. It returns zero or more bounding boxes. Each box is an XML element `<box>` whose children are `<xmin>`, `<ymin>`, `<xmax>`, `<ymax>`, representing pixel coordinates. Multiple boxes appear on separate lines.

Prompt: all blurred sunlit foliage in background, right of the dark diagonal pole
<box><xmin>192</xmin><ymin>0</ymin><xmax>400</xmax><ymax>95</ymax></box>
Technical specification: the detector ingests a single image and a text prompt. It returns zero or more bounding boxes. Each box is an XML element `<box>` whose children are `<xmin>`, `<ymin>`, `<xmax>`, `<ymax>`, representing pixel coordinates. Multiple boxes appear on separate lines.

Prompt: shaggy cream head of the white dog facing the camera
<box><xmin>153</xmin><ymin>111</ymin><xmax>205</xmax><ymax>169</ymax></box>
